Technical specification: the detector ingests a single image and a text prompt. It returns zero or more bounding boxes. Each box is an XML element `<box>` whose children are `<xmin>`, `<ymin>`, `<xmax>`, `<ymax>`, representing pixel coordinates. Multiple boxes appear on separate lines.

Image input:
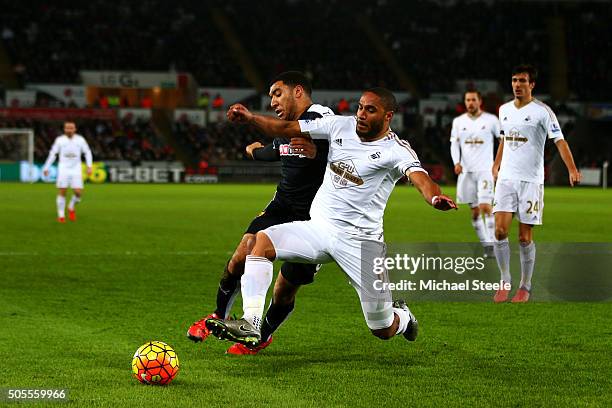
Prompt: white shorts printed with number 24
<box><xmin>493</xmin><ymin>180</ymin><xmax>544</xmax><ymax>225</ymax></box>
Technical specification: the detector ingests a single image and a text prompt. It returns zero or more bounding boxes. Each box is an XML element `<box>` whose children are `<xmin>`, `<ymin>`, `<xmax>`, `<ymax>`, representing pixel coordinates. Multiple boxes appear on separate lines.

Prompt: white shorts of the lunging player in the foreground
<box><xmin>262</xmin><ymin>220</ymin><xmax>394</xmax><ymax>330</ymax></box>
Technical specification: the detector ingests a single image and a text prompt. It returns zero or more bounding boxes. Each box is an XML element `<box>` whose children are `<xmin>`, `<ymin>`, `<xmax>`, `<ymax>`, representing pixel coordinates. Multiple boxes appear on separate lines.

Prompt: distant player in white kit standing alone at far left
<box><xmin>43</xmin><ymin>121</ymin><xmax>92</xmax><ymax>223</ymax></box>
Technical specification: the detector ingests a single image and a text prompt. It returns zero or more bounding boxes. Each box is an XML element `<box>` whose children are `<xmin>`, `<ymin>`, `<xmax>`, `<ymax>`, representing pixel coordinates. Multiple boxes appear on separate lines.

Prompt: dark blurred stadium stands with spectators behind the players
<box><xmin>0</xmin><ymin>0</ymin><xmax>612</xmax><ymax>182</ymax></box>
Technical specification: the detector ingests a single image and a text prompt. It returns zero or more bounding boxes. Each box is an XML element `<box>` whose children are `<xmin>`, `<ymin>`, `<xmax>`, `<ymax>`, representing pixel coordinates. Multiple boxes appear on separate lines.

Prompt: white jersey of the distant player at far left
<box><xmin>43</xmin><ymin>134</ymin><xmax>92</xmax><ymax>174</ymax></box>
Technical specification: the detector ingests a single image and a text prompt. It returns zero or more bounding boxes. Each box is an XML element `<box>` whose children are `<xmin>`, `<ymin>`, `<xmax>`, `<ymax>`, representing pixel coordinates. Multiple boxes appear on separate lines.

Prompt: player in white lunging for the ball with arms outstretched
<box><xmin>206</xmin><ymin>88</ymin><xmax>457</xmax><ymax>345</ymax></box>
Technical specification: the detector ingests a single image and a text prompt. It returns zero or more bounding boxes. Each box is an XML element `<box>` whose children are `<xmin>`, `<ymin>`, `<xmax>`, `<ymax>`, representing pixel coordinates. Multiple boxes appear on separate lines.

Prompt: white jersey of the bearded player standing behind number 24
<box><xmin>451</xmin><ymin>112</ymin><xmax>501</xmax><ymax>172</ymax></box>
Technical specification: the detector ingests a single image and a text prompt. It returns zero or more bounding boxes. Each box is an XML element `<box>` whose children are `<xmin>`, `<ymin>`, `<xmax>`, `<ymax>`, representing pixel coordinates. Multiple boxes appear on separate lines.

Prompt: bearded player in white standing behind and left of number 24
<box><xmin>450</xmin><ymin>90</ymin><xmax>500</xmax><ymax>257</ymax></box>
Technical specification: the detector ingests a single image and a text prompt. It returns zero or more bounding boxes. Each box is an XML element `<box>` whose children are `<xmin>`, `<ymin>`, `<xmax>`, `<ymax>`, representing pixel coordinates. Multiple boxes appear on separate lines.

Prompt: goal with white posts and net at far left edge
<box><xmin>0</xmin><ymin>128</ymin><xmax>34</xmax><ymax>181</ymax></box>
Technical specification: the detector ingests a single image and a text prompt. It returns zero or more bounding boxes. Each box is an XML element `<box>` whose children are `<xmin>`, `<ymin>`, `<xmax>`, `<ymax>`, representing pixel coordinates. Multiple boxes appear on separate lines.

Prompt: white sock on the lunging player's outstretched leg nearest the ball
<box><xmin>240</xmin><ymin>255</ymin><xmax>273</xmax><ymax>330</ymax></box>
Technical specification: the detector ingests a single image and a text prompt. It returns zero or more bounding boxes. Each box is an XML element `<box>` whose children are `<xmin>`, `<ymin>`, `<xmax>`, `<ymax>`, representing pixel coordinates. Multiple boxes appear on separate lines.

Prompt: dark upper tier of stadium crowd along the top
<box><xmin>0</xmin><ymin>0</ymin><xmax>612</xmax><ymax>100</ymax></box>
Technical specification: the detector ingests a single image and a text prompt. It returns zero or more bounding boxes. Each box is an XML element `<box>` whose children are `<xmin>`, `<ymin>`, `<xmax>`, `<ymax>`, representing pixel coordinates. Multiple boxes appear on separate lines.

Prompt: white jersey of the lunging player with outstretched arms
<box><xmin>299</xmin><ymin>116</ymin><xmax>425</xmax><ymax>236</ymax></box>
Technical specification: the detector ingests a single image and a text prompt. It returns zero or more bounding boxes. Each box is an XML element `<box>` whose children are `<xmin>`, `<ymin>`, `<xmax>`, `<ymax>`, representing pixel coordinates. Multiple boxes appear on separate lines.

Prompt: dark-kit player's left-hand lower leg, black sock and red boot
<box><xmin>187</xmin><ymin>234</ymin><xmax>255</xmax><ymax>342</ymax></box>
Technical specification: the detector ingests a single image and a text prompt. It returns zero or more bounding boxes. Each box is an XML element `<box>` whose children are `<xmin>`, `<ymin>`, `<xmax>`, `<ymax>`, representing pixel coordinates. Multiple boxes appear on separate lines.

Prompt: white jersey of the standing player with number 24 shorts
<box><xmin>498</xmin><ymin>99</ymin><xmax>563</xmax><ymax>184</ymax></box>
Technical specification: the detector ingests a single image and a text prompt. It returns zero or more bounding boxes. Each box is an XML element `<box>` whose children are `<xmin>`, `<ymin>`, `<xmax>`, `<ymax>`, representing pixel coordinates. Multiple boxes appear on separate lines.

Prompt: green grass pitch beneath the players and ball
<box><xmin>0</xmin><ymin>184</ymin><xmax>612</xmax><ymax>407</ymax></box>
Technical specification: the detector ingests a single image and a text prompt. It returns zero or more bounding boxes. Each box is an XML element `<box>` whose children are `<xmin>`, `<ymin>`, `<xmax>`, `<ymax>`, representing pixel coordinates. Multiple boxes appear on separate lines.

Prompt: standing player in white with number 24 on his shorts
<box><xmin>493</xmin><ymin>65</ymin><xmax>580</xmax><ymax>303</ymax></box>
